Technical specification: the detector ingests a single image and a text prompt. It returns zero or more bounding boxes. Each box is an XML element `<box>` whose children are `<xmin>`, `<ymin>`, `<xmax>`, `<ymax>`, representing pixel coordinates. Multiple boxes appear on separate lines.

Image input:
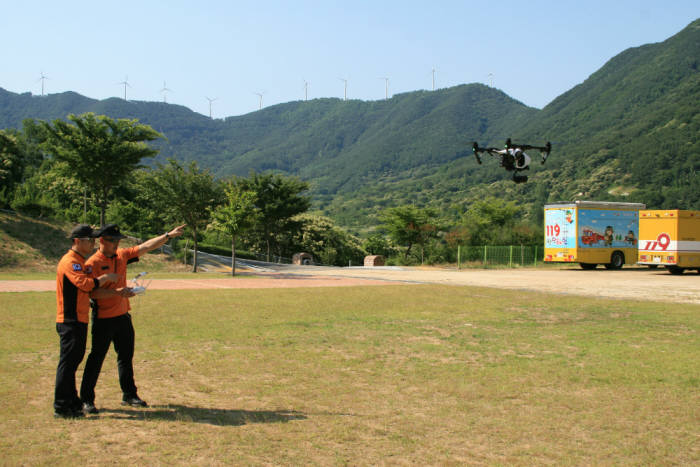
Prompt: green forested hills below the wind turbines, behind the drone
<box><xmin>0</xmin><ymin>20</ymin><xmax>700</xmax><ymax>230</ymax></box>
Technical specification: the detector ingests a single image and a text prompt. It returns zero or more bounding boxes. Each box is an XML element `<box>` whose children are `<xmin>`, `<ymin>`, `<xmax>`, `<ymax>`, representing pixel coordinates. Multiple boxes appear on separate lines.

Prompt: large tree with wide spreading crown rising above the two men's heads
<box><xmin>42</xmin><ymin>113</ymin><xmax>163</xmax><ymax>225</ymax></box>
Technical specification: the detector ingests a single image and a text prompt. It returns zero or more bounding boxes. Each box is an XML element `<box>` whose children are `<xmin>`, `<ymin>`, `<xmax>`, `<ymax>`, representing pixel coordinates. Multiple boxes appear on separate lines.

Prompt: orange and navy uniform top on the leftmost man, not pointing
<box><xmin>56</xmin><ymin>250</ymin><xmax>99</xmax><ymax>323</ymax></box>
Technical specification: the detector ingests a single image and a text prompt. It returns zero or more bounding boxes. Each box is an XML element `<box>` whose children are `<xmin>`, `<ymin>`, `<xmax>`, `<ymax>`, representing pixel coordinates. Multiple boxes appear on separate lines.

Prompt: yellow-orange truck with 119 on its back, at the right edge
<box><xmin>639</xmin><ymin>209</ymin><xmax>700</xmax><ymax>274</ymax></box>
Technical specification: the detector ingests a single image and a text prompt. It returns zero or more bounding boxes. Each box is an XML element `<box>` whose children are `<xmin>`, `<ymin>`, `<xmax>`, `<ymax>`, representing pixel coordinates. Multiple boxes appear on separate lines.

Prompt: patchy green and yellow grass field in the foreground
<box><xmin>0</xmin><ymin>285</ymin><xmax>700</xmax><ymax>465</ymax></box>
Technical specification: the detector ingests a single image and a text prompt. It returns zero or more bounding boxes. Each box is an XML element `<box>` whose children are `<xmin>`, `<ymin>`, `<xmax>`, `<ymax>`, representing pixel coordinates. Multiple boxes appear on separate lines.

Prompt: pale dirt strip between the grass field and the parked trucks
<box><xmin>0</xmin><ymin>266</ymin><xmax>700</xmax><ymax>304</ymax></box>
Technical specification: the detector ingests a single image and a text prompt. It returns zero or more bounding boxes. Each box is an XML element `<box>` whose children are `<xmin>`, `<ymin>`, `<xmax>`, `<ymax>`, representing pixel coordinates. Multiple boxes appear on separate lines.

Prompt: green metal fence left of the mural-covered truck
<box><xmin>457</xmin><ymin>245</ymin><xmax>542</xmax><ymax>269</ymax></box>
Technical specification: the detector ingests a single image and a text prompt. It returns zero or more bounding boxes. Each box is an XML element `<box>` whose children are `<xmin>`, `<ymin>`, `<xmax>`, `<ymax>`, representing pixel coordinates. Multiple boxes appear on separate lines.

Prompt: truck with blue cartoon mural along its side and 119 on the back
<box><xmin>544</xmin><ymin>201</ymin><xmax>646</xmax><ymax>269</ymax></box>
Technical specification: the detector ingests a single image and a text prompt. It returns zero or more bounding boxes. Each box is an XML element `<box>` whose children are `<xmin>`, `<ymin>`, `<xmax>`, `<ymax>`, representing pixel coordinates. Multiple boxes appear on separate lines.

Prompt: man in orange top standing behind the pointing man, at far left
<box><xmin>53</xmin><ymin>224</ymin><xmax>117</xmax><ymax>418</ymax></box>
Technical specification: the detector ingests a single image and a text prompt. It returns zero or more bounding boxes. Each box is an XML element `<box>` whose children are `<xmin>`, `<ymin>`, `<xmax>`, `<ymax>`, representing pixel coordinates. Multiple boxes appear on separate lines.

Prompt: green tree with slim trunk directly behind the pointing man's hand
<box><xmin>154</xmin><ymin>159</ymin><xmax>221</xmax><ymax>272</ymax></box>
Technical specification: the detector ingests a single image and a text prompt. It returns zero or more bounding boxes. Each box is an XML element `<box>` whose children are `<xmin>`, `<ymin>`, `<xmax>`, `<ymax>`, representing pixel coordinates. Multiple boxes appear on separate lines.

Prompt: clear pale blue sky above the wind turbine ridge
<box><xmin>0</xmin><ymin>0</ymin><xmax>700</xmax><ymax>118</ymax></box>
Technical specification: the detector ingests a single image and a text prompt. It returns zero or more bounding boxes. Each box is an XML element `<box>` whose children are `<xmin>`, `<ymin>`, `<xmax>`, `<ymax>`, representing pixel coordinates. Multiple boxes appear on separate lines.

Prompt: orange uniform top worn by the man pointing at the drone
<box><xmin>87</xmin><ymin>246</ymin><xmax>139</xmax><ymax>318</ymax></box>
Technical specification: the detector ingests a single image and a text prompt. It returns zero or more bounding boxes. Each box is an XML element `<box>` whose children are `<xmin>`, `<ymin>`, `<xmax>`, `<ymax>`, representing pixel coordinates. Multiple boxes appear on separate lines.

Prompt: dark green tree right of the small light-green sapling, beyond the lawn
<box><xmin>240</xmin><ymin>172</ymin><xmax>311</xmax><ymax>261</ymax></box>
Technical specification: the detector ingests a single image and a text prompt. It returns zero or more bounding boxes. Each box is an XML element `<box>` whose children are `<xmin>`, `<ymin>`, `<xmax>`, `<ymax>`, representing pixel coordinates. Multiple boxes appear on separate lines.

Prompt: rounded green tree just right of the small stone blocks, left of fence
<box><xmin>381</xmin><ymin>206</ymin><xmax>439</xmax><ymax>264</ymax></box>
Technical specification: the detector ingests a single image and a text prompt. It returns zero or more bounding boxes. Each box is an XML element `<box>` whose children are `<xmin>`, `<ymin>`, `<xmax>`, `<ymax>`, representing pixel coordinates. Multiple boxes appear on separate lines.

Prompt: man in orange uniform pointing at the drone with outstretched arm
<box><xmin>80</xmin><ymin>224</ymin><xmax>185</xmax><ymax>413</ymax></box>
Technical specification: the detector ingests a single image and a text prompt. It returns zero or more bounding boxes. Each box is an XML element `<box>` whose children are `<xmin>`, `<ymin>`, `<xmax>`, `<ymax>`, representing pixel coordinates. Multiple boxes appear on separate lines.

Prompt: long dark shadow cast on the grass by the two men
<box><xmin>100</xmin><ymin>404</ymin><xmax>307</xmax><ymax>426</ymax></box>
